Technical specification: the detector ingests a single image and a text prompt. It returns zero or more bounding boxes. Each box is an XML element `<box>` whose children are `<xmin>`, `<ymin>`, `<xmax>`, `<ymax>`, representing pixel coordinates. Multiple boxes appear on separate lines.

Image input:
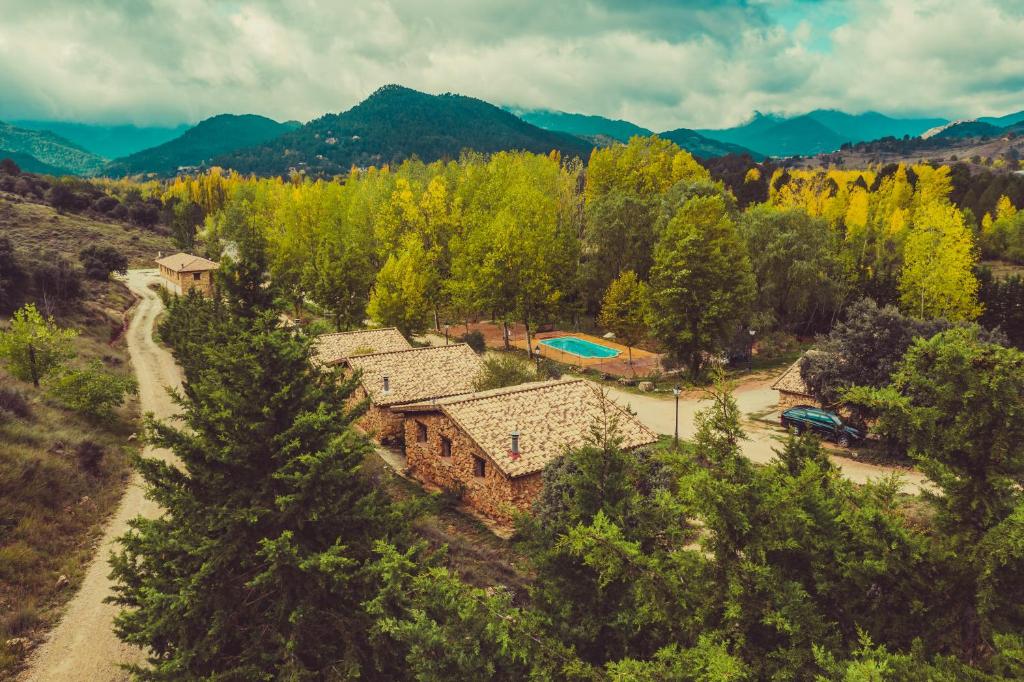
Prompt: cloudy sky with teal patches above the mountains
<box><xmin>0</xmin><ymin>0</ymin><xmax>1024</xmax><ymax>130</ymax></box>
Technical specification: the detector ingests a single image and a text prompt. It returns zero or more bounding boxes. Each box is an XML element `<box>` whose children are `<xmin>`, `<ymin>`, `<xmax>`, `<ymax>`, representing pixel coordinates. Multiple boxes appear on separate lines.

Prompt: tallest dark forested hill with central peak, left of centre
<box><xmin>214</xmin><ymin>85</ymin><xmax>593</xmax><ymax>175</ymax></box>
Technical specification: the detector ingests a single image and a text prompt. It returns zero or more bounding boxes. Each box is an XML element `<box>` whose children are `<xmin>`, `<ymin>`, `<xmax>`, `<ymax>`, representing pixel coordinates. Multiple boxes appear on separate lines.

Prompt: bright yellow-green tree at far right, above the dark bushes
<box><xmin>899</xmin><ymin>202</ymin><xmax>981</xmax><ymax>322</ymax></box>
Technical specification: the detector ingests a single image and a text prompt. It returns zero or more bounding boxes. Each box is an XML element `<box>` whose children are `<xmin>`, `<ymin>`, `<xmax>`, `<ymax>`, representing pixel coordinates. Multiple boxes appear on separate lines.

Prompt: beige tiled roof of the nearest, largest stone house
<box><xmin>402</xmin><ymin>379</ymin><xmax>657</xmax><ymax>477</ymax></box>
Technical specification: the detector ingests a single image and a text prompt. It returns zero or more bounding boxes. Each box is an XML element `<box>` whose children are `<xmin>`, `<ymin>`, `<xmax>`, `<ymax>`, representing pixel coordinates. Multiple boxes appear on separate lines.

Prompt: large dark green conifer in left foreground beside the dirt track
<box><xmin>112</xmin><ymin>313</ymin><xmax>401</xmax><ymax>680</ymax></box>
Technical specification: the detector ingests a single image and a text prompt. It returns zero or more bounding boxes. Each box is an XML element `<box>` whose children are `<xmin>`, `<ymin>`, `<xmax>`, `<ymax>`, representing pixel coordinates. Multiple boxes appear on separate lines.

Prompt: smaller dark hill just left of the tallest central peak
<box><xmin>104</xmin><ymin>114</ymin><xmax>298</xmax><ymax>176</ymax></box>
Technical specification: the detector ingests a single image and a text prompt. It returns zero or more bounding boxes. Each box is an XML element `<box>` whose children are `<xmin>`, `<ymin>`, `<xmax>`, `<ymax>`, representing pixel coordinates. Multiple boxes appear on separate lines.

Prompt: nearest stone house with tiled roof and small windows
<box><xmin>394</xmin><ymin>379</ymin><xmax>657</xmax><ymax>522</ymax></box>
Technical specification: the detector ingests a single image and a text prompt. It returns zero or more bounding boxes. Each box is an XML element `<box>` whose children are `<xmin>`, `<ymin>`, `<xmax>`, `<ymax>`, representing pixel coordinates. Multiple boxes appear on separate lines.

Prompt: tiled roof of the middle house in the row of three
<box><xmin>348</xmin><ymin>343</ymin><xmax>483</xmax><ymax>406</ymax></box>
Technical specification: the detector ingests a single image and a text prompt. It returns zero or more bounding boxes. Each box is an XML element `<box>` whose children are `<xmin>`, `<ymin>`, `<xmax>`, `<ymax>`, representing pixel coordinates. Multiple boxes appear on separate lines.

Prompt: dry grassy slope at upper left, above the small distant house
<box><xmin>0</xmin><ymin>193</ymin><xmax>176</xmax><ymax>267</ymax></box>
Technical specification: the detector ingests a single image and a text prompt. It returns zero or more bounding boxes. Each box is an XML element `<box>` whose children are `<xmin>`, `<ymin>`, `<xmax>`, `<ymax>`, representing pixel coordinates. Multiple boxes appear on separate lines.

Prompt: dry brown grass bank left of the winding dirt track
<box><xmin>0</xmin><ymin>236</ymin><xmax>146</xmax><ymax>679</ymax></box>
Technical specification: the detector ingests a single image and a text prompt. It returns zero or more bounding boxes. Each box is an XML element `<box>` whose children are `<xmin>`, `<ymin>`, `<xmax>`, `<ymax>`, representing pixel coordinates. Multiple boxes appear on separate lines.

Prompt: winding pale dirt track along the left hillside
<box><xmin>18</xmin><ymin>270</ymin><xmax>181</xmax><ymax>682</ymax></box>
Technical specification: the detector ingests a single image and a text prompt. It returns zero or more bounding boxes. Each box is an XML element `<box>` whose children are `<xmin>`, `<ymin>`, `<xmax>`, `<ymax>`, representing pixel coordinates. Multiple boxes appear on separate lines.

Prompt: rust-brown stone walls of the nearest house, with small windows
<box><xmin>404</xmin><ymin>413</ymin><xmax>543</xmax><ymax>522</ymax></box>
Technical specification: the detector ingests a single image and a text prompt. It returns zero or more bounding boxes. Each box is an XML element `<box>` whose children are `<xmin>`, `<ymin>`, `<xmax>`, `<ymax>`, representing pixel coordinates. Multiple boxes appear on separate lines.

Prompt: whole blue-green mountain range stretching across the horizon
<box><xmin>0</xmin><ymin>85</ymin><xmax>1024</xmax><ymax>176</ymax></box>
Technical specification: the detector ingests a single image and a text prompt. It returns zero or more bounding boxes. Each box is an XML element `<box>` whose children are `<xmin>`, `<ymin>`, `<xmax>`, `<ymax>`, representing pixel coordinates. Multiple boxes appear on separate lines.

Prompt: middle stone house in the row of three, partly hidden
<box><xmin>345</xmin><ymin>343</ymin><xmax>483</xmax><ymax>442</ymax></box>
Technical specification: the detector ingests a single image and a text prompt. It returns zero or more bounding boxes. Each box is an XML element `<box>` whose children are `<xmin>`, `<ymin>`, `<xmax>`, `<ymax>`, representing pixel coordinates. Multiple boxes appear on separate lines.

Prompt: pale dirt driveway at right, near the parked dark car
<box><xmin>608</xmin><ymin>381</ymin><xmax>928</xmax><ymax>495</ymax></box>
